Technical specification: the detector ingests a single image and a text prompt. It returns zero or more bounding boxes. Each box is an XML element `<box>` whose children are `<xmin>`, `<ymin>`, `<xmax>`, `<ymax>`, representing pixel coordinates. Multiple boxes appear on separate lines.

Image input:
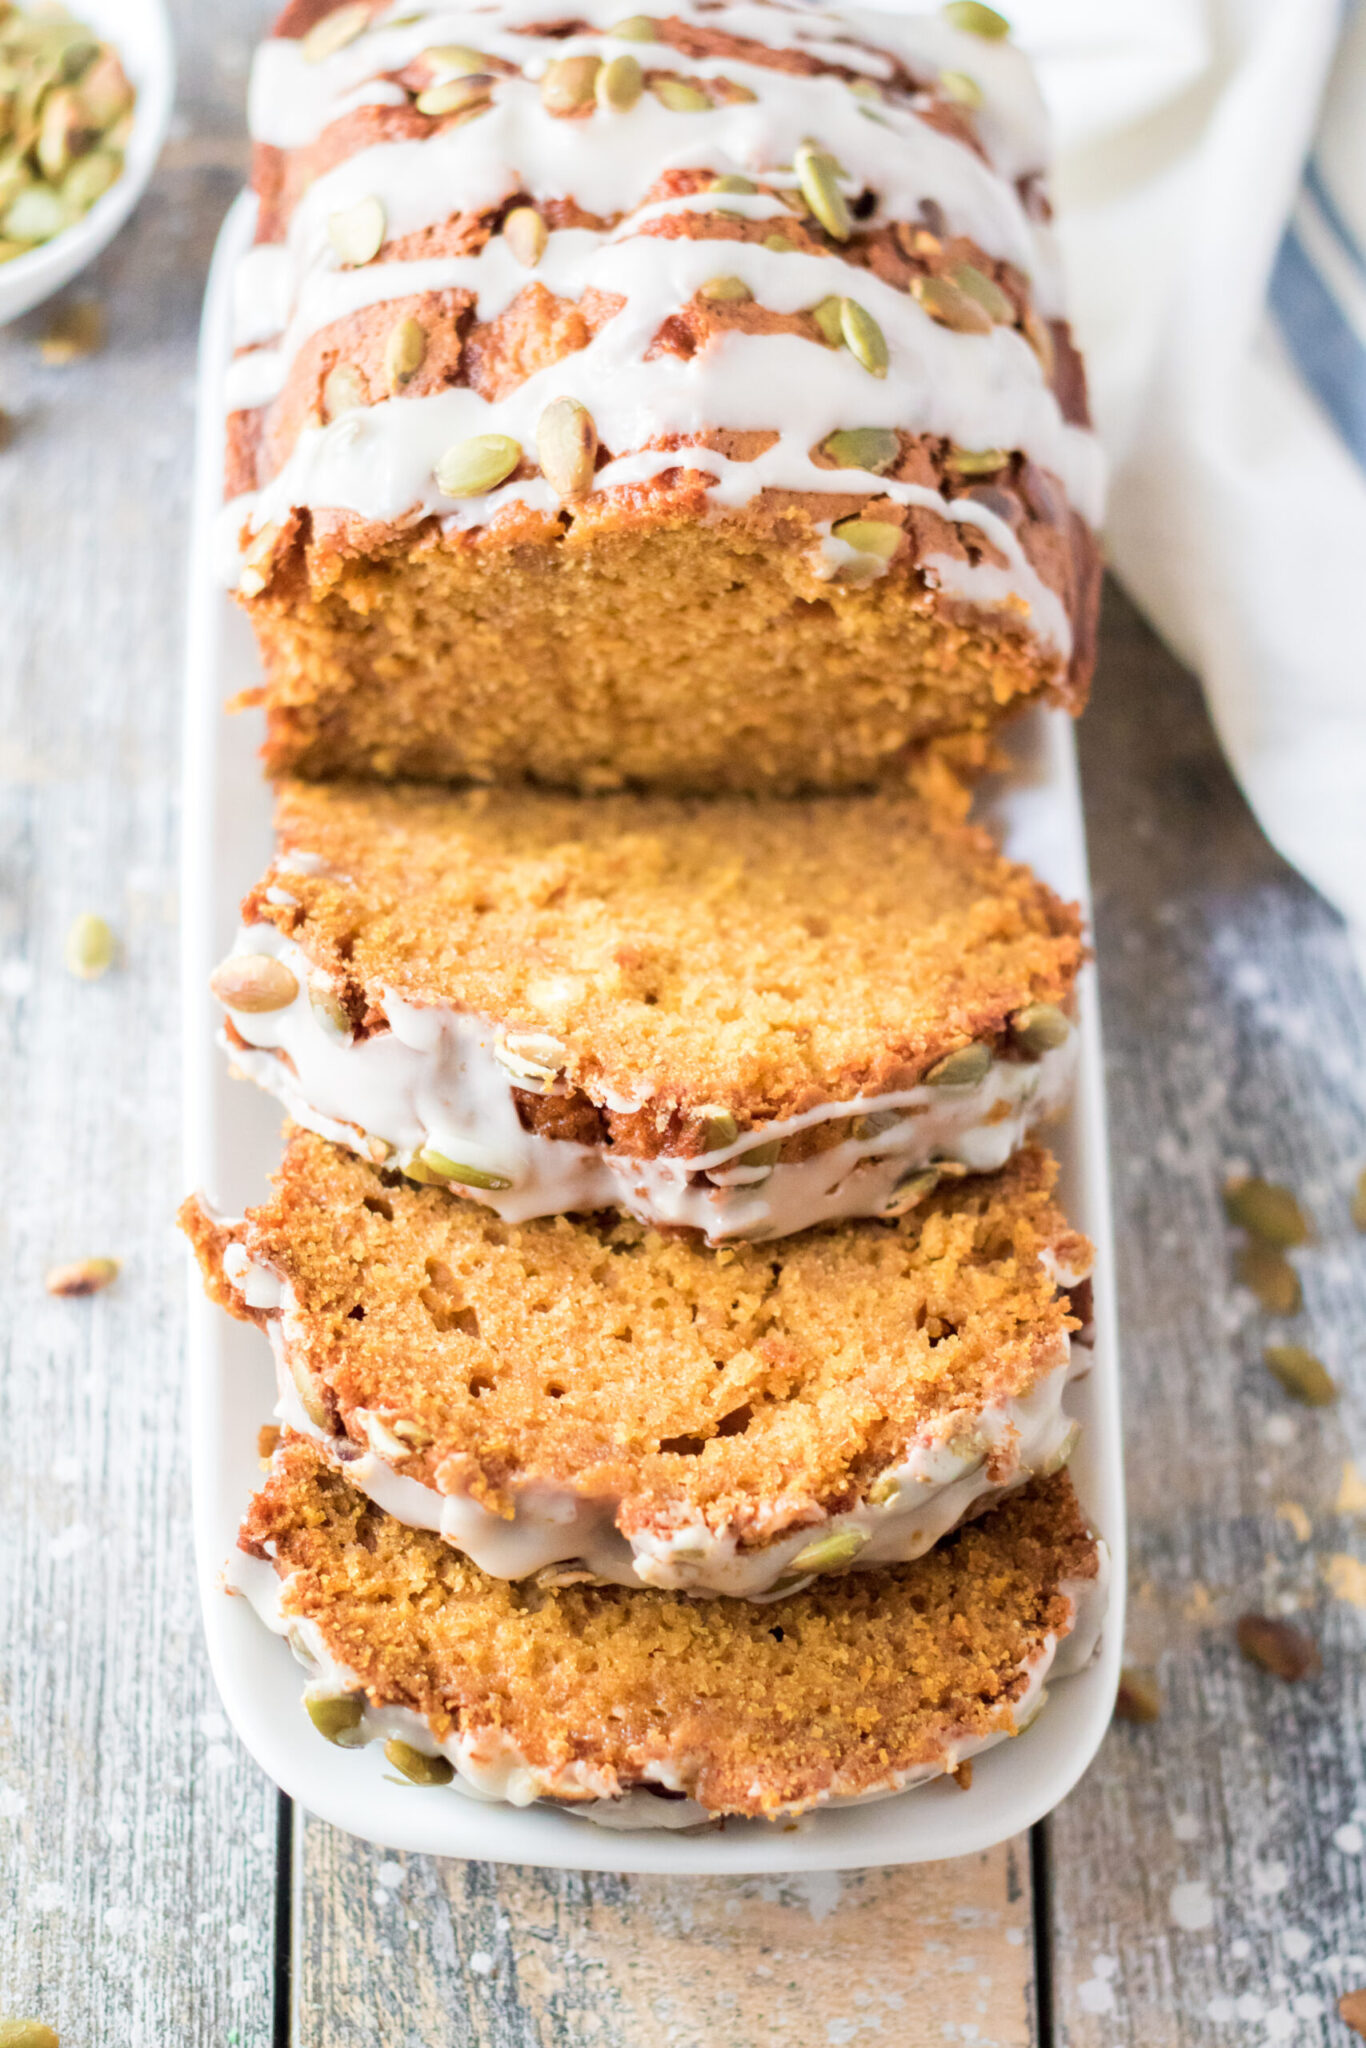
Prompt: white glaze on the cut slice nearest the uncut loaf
<box><xmin>227</xmin><ymin>924</ymin><xmax>1075</xmax><ymax>1243</ymax></box>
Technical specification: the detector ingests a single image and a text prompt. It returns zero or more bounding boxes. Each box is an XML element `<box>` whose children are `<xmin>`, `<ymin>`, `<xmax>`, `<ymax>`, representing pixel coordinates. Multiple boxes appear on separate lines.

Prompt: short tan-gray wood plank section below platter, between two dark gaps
<box><xmin>297</xmin><ymin>1821</ymin><xmax>1032</xmax><ymax>2048</ymax></box>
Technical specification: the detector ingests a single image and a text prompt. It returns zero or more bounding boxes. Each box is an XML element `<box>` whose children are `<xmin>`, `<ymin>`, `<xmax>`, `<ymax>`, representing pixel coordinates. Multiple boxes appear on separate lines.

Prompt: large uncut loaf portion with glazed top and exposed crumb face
<box><xmin>227</xmin><ymin>0</ymin><xmax>1100</xmax><ymax>791</ymax></box>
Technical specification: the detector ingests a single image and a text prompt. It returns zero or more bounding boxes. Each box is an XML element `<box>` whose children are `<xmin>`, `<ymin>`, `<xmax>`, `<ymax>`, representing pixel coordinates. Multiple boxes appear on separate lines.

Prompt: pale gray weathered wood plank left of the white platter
<box><xmin>0</xmin><ymin>4</ymin><xmax>276</xmax><ymax>2048</ymax></box>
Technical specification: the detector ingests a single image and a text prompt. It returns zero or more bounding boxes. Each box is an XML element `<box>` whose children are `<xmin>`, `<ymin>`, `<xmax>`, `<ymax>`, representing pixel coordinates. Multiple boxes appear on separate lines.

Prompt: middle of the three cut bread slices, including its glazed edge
<box><xmin>182</xmin><ymin>1130</ymin><xmax>1092</xmax><ymax>1597</ymax></box>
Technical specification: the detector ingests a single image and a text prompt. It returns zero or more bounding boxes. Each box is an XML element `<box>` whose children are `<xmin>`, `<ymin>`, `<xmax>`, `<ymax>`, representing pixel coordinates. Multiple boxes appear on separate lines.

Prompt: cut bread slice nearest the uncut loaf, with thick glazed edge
<box><xmin>215</xmin><ymin>782</ymin><xmax>1081</xmax><ymax>1241</ymax></box>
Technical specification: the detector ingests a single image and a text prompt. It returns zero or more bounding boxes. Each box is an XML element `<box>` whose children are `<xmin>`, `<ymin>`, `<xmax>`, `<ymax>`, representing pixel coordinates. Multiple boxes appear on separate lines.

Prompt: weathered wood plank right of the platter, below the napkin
<box><xmin>1051</xmin><ymin>585</ymin><xmax>1366</xmax><ymax>2048</ymax></box>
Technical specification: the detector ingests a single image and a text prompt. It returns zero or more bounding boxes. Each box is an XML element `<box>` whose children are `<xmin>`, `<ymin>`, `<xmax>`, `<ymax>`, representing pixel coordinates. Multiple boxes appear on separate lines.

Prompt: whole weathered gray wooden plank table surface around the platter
<box><xmin>0</xmin><ymin>0</ymin><xmax>1366</xmax><ymax>2048</ymax></box>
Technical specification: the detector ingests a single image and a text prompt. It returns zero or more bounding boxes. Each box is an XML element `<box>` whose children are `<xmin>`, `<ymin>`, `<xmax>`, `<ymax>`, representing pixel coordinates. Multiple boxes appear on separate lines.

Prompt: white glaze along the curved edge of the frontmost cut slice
<box><xmin>225</xmin><ymin>1542</ymin><xmax>1108</xmax><ymax>1829</ymax></box>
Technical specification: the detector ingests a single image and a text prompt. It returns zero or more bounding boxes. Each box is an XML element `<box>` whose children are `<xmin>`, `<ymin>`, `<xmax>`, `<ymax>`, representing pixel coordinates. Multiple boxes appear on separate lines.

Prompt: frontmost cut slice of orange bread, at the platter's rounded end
<box><xmin>229</xmin><ymin>1436</ymin><xmax>1104</xmax><ymax>1825</ymax></box>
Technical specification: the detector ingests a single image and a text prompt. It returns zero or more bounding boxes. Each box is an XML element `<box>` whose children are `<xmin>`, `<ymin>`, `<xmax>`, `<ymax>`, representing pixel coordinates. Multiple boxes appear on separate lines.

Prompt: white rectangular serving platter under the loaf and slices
<box><xmin>182</xmin><ymin>199</ymin><xmax>1124</xmax><ymax>1876</ymax></box>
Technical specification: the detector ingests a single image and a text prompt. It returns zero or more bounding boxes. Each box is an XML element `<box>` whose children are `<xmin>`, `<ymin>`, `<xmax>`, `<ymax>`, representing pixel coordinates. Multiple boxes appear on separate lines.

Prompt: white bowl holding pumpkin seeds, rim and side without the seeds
<box><xmin>0</xmin><ymin>0</ymin><xmax>176</xmax><ymax>326</ymax></box>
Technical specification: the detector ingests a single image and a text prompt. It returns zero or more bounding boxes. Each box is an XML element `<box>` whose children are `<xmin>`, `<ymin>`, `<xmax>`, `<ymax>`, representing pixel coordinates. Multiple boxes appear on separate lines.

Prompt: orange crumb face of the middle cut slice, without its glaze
<box><xmin>180</xmin><ymin>1128</ymin><xmax>1092</xmax><ymax>1546</ymax></box>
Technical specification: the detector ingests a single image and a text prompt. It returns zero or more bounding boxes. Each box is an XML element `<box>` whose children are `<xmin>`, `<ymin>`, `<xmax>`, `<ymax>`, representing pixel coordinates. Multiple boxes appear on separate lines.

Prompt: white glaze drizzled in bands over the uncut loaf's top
<box><xmin>231</xmin><ymin>0</ymin><xmax>1102</xmax><ymax>643</ymax></box>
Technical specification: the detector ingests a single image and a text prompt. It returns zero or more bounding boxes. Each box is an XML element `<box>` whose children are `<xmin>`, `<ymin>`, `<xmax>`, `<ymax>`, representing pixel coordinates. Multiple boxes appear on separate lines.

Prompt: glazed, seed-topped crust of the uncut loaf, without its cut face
<box><xmin>229</xmin><ymin>0</ymin><xmax>1100</xmax><ymax>659</ymax></box>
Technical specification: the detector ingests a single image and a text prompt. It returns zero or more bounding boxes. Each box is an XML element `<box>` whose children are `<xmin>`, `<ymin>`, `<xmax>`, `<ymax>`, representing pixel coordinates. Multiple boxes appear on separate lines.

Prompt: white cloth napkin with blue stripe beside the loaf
<box><xmin>1001</xmin><ymin>0</ymin><xmax>1366</xmax><ymax>965</ymax></box>
